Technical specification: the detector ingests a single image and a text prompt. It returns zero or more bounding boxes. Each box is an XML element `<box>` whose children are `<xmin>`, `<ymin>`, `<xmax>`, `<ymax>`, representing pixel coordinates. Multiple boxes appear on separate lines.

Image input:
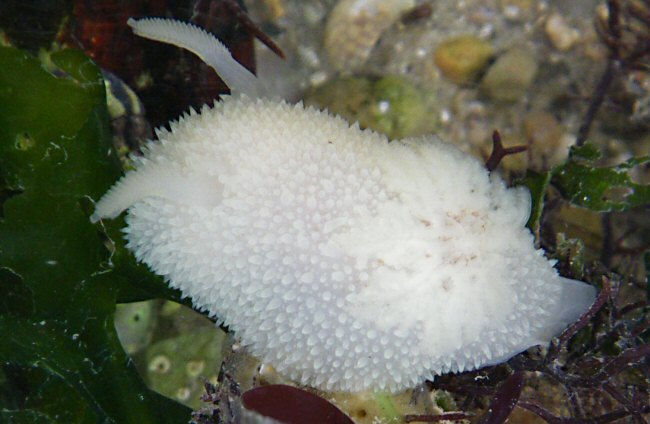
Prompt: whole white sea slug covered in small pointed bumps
<box><xmin>92</xmin><ymin>19</ymin><xmax>595</xmax><ymax>391</ymax></box>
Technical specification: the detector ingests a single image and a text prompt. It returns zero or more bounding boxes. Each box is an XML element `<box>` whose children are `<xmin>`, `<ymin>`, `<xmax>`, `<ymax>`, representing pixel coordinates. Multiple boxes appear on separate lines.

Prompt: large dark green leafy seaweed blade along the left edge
<box><xmin>0</xmin><ymin>48</ymin><xmax>189</xmax><ymax>423</ymax></box>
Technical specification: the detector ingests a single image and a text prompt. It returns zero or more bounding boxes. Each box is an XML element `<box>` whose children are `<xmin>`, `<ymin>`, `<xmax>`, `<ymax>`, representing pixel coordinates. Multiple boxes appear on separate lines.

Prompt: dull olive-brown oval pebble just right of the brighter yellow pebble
<box><xmin>481</xmin><ymin>48</ymin><xmax>538</xmax><ymax>102</ymax></box>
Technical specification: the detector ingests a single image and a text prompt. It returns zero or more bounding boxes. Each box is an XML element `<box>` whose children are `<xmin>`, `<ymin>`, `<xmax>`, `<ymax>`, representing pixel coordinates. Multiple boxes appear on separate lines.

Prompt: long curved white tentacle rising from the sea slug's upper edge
<box><xmin>128</xmin><ymin>18</ymin><xmax>268</xmax><ymax>98</ymax></box>
